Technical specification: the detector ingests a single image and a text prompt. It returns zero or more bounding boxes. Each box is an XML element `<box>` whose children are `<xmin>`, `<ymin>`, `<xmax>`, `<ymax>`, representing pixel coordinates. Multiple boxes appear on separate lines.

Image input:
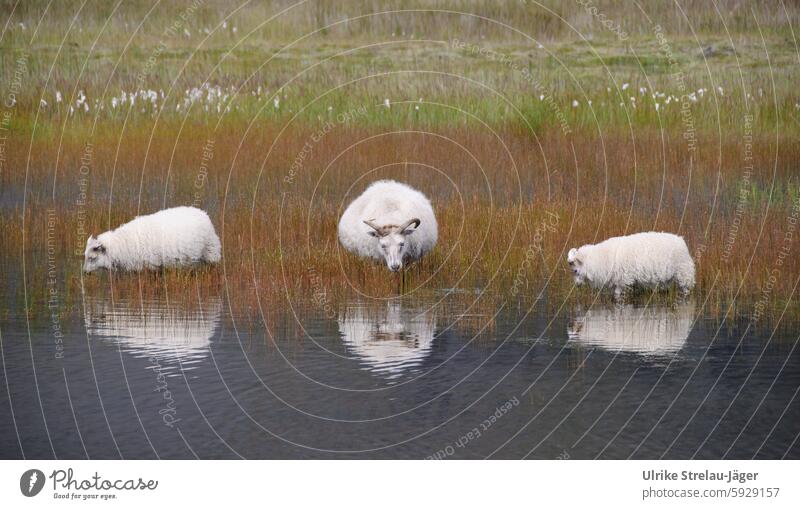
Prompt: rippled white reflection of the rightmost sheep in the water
<box><xmin>567</xmin><ymin>302</ymin><xmax>694</xmax><ymax>355</ymax></box>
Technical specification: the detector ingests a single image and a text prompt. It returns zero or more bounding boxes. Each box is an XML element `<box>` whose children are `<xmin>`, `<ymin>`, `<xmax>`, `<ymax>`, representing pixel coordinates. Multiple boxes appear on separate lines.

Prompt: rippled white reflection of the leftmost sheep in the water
<box><xmin>84</xmin><ymin>298</ymin><xmax>222</xmax><ymax>371</ymax></box>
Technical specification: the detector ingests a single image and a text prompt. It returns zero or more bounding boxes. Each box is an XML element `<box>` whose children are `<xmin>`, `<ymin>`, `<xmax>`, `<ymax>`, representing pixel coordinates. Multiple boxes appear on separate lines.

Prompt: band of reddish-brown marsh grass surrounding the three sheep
<box><xmin>0</xmin><ymin>123</ymin><xmax>800</xmax><ymax>322</ymax></box>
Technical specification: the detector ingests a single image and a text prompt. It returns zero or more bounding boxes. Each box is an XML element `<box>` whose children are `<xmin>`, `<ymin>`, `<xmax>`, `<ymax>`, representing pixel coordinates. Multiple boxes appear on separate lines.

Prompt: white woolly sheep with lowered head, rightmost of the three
<box><xmin>567</xmin><ymin>232</ymin><xmax>694</xmax><ymax>299</ymax></box>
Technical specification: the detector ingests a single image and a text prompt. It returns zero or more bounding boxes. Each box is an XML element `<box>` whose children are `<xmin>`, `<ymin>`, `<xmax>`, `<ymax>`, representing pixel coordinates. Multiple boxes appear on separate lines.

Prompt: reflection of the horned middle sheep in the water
<box><xmin>339</xmin><ymin>302</ymin><xmax>436</xmax><ymax>379</ymax></box>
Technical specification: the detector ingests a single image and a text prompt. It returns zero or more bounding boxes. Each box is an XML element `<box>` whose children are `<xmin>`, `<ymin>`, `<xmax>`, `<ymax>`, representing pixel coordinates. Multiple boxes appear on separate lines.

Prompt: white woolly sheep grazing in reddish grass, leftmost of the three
<box><xmin>83</xmin><ymin>207</ymin><xmax>221</xmax><ymax>272</ymax></box>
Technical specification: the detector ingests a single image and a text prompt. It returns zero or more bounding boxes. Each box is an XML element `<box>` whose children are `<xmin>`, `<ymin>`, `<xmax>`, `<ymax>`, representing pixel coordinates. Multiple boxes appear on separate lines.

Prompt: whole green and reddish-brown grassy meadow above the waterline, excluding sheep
<box><xmin>0</xmin><ymin>0</ymin><xmax>800</xmax><ymax>319</ymax></box>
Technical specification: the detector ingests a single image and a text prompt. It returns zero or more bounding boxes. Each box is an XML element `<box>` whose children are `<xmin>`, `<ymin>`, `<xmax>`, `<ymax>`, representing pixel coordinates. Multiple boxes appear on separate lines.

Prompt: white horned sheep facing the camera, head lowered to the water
<box><xmin>339</xmin><ymin>180</ymin><xmax>438</xmax><ymax>272</ymax></box>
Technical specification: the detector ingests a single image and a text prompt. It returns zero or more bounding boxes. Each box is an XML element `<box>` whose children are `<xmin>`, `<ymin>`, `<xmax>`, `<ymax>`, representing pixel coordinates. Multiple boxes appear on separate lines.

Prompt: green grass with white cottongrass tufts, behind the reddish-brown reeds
<box><xmin>0</xmin><ymin>0</ymin><xmax>800</xmax><ymax>130</ymax></box>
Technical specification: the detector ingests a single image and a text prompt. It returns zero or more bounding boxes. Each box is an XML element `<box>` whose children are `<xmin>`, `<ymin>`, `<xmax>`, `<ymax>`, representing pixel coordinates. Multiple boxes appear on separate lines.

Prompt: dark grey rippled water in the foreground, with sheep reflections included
<box><xmin>0</xmin><ymin>294</ymin><xmax>800</xmax><ymax>459</ymax></box>
